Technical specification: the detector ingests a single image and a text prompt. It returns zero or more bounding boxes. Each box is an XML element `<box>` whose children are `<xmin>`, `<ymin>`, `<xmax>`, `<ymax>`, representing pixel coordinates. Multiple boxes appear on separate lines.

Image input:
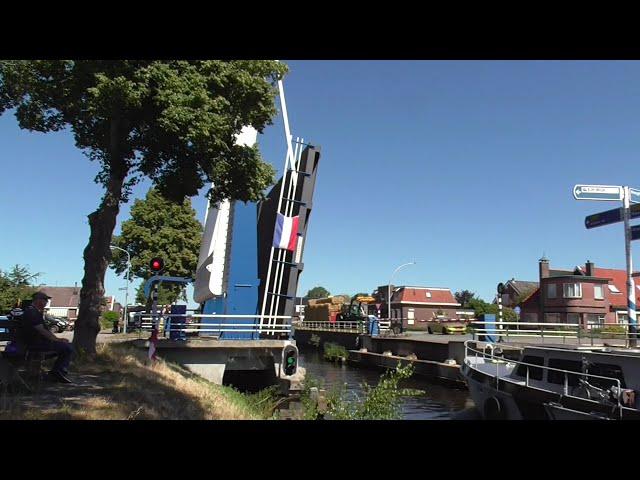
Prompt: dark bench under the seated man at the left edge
<box><xmin>0</xmin><ymin>318</ymin><xmax>57</xmax><ymax>392</ymax></box>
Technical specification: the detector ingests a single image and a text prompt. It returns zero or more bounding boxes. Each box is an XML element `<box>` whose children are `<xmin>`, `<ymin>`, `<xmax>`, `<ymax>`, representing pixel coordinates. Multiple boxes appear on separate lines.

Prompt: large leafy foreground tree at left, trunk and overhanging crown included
<box><xmin>0</xmin><ymin>60</ymin><xmax>287</xmax><ymax>353</ymax></box>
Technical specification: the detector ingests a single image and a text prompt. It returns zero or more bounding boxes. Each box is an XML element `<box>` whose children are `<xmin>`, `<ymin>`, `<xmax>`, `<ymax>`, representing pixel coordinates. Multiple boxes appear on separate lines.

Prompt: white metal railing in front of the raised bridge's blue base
<box><xmin>134</xmin><ymin>313</ymin><xmax>292</xmax><ymax>335</ymax></box>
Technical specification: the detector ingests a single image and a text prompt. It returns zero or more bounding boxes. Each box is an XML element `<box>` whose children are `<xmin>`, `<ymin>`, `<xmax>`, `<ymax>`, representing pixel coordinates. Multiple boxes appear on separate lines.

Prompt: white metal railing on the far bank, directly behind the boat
<box><xmin>469</xmin><ymin>321</ymin><xmax>638</xmax><ymax>346</ymax></box>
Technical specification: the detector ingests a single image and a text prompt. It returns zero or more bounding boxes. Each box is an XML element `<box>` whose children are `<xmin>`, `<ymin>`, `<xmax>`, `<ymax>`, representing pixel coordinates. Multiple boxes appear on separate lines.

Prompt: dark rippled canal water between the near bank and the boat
<box><xmin>299</xmin><ymin>348</ymin><xmax>474</xmax><ymax>420</ymax></box>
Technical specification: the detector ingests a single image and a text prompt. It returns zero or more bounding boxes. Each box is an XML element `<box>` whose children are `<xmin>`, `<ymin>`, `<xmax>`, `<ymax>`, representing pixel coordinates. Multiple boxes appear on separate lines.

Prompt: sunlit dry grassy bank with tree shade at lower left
<box><xmin>0</xmin><ymin>343</ymin><xmax>273</xmax><ymax>420</ymax></box>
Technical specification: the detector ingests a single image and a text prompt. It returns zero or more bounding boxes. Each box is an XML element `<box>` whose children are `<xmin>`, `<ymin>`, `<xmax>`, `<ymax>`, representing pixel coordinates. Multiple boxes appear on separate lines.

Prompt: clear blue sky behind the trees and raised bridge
<box><xmin>0</xmin><ymin>60</ymin><xmax>640</xmax><ymax>308</ymax></box>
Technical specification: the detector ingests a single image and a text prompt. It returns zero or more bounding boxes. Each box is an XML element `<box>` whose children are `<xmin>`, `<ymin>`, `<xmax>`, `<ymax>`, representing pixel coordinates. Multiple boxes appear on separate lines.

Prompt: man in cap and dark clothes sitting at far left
<box><xmin>16</xmin><ymin>291</ymin><xmax>73</xmax><ymax>383</ymax></box>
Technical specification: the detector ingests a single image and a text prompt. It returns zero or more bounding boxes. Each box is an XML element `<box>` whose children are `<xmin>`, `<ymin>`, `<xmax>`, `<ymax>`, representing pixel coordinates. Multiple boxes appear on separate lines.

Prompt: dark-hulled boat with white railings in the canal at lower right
<box><xmin>461</xmin><ymin>340</ymin><xmax>640</xmax><ymax>420</ymax></box>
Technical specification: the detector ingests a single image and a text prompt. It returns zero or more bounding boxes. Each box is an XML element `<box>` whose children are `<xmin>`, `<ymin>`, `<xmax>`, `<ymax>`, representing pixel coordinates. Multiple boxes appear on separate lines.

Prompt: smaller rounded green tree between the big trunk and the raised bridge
<box><xmin>110</xmin><ymin>188</ymin><xmax>202</xmax><ymax>303</ymax></box>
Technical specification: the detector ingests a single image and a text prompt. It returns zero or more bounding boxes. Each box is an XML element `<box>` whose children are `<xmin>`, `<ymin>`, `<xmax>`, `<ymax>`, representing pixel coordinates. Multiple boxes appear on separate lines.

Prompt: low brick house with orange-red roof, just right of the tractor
<box><xmin>373</xmin><ymin>285</ymin><xmax>473</xmax><ymax>330</ymax></box>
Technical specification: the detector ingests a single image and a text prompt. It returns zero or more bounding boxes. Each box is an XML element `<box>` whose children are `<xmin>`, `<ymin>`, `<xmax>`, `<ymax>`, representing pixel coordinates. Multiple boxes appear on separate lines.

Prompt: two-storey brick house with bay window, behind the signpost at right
<box><xmin>521</xmin><ymin>258</ymin><xmax>640</xmax><ymax>328</ymax></box>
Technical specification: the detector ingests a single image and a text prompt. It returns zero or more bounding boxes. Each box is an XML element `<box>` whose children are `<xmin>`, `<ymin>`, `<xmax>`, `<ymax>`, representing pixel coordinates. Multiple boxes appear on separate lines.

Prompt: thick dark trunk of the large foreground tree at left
<box><xmin>73</xmin><ymin>116</ymin><xmax>128</xmax><ymax>356</ymax></box>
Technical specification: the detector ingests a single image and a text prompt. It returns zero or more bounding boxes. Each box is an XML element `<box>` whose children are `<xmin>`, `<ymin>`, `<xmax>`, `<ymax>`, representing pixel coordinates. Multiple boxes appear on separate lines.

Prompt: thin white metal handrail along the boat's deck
<box><xmin>464</xmin><ymin>340</ymin><xmax>622</xmax><ymax>417</ymax></box>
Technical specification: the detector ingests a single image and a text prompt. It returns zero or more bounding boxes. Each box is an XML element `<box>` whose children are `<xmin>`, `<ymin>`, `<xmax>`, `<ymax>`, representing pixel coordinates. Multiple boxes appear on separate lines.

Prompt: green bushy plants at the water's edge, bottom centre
<box><xmin>327</xmin><ymin>363</ymin><xmax>414</xmax><ymax>420</ymax></box>
